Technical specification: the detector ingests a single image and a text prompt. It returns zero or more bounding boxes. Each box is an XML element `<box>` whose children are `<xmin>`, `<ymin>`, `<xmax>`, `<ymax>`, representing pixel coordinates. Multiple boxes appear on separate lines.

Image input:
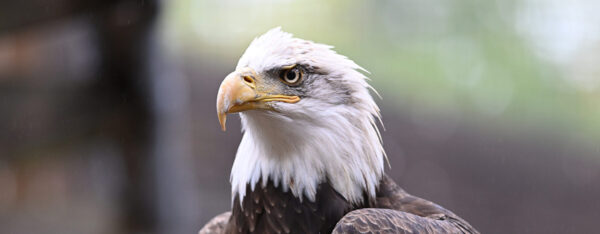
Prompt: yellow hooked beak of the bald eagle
<box><xmin>217</xmin><ymin>67</ymin><xmax>300</xmax><ymax>131</ymax></box>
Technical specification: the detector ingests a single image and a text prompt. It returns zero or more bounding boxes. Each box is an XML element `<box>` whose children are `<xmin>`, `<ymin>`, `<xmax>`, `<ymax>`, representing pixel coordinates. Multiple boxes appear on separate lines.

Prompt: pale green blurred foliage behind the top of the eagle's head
<box><xmin>162</xmin><ymin>0</ymin><xmax>600</xmax><ymax>149</ymax></box>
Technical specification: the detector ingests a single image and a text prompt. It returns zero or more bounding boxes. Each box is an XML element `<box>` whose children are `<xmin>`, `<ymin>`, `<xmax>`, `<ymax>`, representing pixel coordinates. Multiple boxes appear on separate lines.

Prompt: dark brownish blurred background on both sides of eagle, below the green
<box><xmin>0</xmin><ymin>0</ymin><xmax>600</xmax><ymax>233</ymax></box>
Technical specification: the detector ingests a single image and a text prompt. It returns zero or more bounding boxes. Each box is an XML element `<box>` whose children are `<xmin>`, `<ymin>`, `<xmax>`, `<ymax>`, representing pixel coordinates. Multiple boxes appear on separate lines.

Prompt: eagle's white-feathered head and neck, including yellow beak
<box><xmin>217</xmin><ymin>28</ymin><xmax>385</xmax><ymax>206</ymax></box>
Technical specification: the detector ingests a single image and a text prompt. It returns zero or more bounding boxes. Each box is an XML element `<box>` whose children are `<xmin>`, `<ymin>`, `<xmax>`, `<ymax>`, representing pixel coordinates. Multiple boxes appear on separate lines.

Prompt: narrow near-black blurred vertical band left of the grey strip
<box><xmin>92</xmin><ymin>0</ymin><xmax>158</xmax><ymax>233</ymax></box>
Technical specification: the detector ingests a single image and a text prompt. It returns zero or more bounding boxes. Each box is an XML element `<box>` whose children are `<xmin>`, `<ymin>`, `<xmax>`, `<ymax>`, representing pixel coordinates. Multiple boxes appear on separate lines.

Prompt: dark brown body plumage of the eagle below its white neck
<box><xmin>200</xmin><ymin>176</ymin><xmax>478</xmax><ymax>234</ymax></box>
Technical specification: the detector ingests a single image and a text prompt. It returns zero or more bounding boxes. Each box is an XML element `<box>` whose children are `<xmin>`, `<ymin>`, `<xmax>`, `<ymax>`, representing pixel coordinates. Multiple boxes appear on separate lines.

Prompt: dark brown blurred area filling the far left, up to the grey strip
<box><xmin>0</xmin><ymin>1</ymin><xmax>158</xmax><ymax>233</ymax></box>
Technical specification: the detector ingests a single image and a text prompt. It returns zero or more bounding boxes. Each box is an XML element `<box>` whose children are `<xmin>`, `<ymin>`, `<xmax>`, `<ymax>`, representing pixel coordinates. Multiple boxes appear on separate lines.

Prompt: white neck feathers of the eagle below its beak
<box><xmin>231</xmin><ymin>106</ymin><xmax>384</xmax><ymax>207</ymax></box>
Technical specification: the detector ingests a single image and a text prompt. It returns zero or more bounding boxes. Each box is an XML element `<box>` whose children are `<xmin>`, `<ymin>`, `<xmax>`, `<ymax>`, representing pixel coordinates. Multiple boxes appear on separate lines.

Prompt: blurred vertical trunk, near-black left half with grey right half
<box><xmin>90</xmin><ymin>1</ymin><xmax>200</xmax><ymax>234</ymax></box>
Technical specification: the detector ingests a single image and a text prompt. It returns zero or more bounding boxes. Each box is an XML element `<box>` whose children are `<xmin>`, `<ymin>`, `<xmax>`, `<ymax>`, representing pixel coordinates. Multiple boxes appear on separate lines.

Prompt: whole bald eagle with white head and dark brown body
<box><xmin>200</xmin><ymin>28</ymin><xmax>478</xmax><ymax>234</ymax></box>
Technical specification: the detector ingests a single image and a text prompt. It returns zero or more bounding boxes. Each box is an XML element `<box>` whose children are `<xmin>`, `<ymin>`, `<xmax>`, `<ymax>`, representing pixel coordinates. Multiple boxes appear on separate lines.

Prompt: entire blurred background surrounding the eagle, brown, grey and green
<box><xmin>0</xmin><ymin>0</ymin><xmax>600</xmax><ymax>234</ymax></box>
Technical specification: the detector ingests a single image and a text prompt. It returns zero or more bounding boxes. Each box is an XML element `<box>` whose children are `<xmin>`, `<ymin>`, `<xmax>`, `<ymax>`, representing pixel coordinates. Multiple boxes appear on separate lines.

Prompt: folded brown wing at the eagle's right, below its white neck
<box><xmin>333</xmin><ymin>175</ymin><xmax>479</xmax><ymax>233</ymax></box>
